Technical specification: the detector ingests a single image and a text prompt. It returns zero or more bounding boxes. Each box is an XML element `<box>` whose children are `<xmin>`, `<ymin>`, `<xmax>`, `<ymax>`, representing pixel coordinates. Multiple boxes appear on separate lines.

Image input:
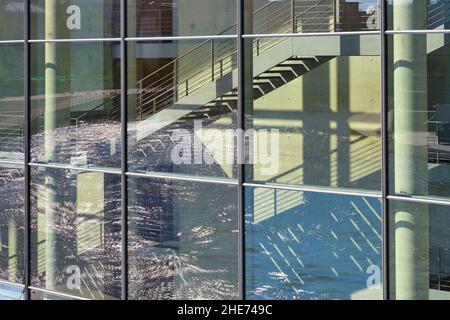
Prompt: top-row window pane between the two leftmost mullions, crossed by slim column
<box><xmin>30</xmin><ymin>0</ymin><xmax>120</xmax><ymax>39</ymax></box>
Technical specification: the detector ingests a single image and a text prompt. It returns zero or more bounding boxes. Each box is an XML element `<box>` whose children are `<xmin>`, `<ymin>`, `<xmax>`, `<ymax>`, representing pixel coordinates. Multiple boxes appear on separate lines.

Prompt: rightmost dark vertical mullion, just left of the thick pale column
<box><xmin>379</xmin><ymin>0</ymin><xmax>390</xmax><ymax>300</ymax></box>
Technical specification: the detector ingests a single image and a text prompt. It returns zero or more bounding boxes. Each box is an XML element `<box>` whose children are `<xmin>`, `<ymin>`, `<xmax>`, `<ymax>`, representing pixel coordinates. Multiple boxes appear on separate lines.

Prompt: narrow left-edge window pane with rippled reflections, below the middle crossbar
<box><xmin>0</xmin><ymin>164</ymin><xmax>25</xmax><ymax>284</ymax></box>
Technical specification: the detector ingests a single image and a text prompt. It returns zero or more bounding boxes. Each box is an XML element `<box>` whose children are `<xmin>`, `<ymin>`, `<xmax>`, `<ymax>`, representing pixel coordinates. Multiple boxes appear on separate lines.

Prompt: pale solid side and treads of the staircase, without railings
<box><xmin>135</xmin><ymin>35</ymin><xmax>384</xmax><ymax>141</ymax></box>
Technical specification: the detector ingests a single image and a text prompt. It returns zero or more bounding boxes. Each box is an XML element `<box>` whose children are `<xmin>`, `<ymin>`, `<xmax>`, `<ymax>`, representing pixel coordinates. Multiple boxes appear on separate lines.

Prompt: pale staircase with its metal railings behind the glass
<box><xmin>131</xmin><ymin>0</ymin><xmax>342</xmax><ymax>141</ymax></box>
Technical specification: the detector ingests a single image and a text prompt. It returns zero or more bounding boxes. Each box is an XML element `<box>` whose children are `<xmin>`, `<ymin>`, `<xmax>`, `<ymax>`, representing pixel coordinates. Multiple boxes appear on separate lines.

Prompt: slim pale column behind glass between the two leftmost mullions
<box><xmin>45</xmin><ymin>0</ymin><xmax>58</xmax><ymax>289</ymax></box>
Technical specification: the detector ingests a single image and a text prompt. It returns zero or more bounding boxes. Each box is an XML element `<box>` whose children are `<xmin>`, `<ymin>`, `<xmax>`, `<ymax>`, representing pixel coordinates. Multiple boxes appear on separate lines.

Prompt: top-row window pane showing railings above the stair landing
<box><xmin>250</xmin><ymin>0</ymin><xmax>380</xmax><ymax>34</ymax></box>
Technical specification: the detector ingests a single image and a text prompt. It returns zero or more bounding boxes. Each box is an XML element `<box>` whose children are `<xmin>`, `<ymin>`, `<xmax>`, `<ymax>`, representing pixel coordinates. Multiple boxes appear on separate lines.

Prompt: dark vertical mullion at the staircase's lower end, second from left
<box><xmin>120</xmin><ymin>0</ymin><xmax>128</xmax><ymax>300</ymax></box>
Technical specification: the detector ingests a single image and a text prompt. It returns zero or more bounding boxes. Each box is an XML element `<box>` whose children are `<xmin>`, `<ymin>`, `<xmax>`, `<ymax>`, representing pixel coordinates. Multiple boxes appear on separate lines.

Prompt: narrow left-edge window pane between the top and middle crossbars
<box><xmin>0</xmin><ymin>44</ymin><xmax>24</xmax><ymax>160</ymax></box>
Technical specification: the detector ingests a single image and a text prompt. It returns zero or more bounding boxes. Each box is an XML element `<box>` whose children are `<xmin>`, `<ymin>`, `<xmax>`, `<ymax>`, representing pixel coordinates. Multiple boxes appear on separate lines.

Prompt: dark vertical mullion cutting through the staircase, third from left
<box><xmin>236</xmin><ymin>0</ymin><xmax>245</xmax><ymax>300</ymax></box>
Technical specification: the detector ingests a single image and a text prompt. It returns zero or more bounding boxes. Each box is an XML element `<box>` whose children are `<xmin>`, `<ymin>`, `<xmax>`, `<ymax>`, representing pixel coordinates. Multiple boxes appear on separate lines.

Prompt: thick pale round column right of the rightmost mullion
<box><xmin>393</xmin><ymin>1</ymin><xmax>429</xmax><ymax>299</ymax></box>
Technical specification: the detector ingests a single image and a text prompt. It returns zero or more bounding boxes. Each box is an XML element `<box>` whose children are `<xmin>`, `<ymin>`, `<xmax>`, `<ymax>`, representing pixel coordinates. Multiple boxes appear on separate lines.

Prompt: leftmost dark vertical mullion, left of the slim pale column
<box><xmin>23</xmin><ymin>0</ymin><xmax>31</xmax><ymax>300</ymax></box>
